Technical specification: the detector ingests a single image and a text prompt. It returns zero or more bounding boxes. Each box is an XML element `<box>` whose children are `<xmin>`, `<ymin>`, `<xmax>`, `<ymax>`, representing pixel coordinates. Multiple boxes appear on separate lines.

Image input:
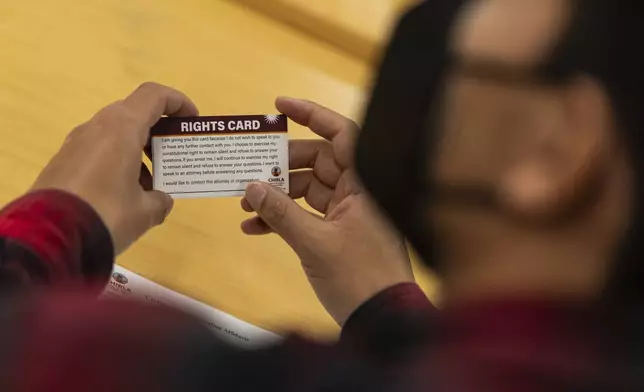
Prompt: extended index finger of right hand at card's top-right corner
<box><xmin>275</xmin><ymin>97</ymin><xmax>358</xmax><ymax>140</ymax></box>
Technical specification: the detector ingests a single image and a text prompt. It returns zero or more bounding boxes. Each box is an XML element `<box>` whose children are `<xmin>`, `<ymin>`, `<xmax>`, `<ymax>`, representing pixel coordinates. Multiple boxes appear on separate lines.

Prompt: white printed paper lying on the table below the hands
<box><xmin>103</xmin><ymin>265</ymin><xmax>282</xmax><ymax>348</ymax></box>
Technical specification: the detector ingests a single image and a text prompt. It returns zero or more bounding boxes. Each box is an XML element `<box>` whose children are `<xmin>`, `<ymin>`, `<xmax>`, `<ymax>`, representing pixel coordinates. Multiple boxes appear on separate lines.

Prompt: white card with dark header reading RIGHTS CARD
<box><xmin>151</xmin><ymin>115</ymin><xmax>289</xmax><ymax>198</ymax></box>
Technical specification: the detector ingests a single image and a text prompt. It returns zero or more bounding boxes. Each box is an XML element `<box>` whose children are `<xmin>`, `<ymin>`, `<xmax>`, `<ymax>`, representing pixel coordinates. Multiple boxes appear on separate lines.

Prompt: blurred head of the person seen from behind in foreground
<box><xmin>357</xmin><ymin>0</ymin><xmax>644</xmax><ymax>299</ymax></box>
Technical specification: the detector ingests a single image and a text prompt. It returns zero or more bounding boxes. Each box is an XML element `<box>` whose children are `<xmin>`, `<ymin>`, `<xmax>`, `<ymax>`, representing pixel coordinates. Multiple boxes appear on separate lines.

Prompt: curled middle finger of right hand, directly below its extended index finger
<box><xmin>289</xmin><ymin>140</ymin><xmax>342</xmax><ymax>188</ymax></box>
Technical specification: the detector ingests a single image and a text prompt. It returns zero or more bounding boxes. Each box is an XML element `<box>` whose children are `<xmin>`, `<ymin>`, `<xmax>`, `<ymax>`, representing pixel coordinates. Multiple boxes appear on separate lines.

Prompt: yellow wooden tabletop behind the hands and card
<box><xmin>0</xmin><ymin>0</ymin><xmax>436</xmax><ymax>337</ymax></box>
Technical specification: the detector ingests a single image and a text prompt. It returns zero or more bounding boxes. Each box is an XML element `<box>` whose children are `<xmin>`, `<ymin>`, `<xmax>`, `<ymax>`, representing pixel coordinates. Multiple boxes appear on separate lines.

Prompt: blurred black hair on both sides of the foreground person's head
<box><xmin>356</xmin><ymin>0</ymin><xmax>644</xmax><ymax>301</ymax></box>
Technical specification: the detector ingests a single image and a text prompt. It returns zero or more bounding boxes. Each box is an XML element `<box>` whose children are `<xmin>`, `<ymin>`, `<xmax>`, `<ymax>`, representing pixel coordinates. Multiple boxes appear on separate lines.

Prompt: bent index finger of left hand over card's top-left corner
<box><xmin>123</xmin><ymin>82</ymin><xmax>199</xmax><ymax>131</ymax></box>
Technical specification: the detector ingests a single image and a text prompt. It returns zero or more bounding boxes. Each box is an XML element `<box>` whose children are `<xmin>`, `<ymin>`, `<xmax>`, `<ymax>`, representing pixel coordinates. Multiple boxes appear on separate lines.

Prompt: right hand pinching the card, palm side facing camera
<box><xmin>242</xmin><ymin>98</ymin><xmax>414</xmax><ymax>325</ymax></box>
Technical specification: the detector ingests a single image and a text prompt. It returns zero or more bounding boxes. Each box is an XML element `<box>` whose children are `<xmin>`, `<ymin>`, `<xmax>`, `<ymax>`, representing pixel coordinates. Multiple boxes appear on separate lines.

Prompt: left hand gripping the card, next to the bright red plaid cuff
<box><xmin>32</xmin><ymin>83</ymin><xmax>198</xmax><ymax>254</ymax></box>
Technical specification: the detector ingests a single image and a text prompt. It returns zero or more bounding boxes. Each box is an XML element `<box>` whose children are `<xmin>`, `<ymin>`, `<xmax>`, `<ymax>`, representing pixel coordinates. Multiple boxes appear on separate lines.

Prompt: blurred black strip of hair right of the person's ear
<box><xmin>547</xmin><ymin>0</ymin><xmax>644</xmax><ymax>304</ymax></box>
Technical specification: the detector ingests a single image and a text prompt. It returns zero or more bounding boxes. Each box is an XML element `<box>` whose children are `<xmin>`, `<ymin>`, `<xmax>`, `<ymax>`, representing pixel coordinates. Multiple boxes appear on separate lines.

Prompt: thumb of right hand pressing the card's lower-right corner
<box><xmin>246</xmin><ymin>182</ymin><xmax>323</xmax><ymax>248</ymax></box>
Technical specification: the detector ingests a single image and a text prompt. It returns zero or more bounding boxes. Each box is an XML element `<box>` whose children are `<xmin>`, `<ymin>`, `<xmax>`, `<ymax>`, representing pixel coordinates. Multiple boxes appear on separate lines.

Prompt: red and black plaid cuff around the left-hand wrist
<box><xmin>0</xmin><ymin>190</ymin><xmax>114</xmax><ymax>290</ymax></box>
